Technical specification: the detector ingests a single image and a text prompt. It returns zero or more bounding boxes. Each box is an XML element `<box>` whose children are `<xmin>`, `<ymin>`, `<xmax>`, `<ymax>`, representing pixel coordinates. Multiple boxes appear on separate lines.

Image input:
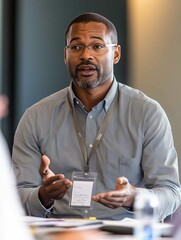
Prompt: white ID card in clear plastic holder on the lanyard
<box><xmin>70</xmin><ymin>172</ymin><xmax>97</xmax><ymax>209</ymax></box>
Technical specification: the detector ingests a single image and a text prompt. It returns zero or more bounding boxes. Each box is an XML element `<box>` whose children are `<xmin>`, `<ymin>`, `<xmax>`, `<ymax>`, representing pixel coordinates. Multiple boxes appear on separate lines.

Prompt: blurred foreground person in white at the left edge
<box><xmin>0</xmin><ymin>95</ymin><xmax>33</xmax><ymax>240</ymax></box>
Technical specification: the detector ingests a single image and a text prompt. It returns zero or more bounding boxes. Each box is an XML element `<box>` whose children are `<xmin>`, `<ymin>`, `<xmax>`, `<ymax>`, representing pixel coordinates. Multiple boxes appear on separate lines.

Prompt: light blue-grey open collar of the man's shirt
<box><xmin>69</xmin><ymin>77</ymin><xmax>117</xmax><ymax>112</ymax></box>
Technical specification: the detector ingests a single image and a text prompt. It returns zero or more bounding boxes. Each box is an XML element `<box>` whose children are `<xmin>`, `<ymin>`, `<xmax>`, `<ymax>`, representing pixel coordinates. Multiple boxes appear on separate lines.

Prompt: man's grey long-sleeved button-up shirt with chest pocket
<box><xmin>13</xmin><ymin>80</ymin><xmax>181</xmax><ymax>219</ymax></box>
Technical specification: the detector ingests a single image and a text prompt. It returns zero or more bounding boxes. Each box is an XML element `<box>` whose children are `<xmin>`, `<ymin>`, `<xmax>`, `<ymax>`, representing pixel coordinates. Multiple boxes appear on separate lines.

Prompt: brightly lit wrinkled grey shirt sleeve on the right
<box><xmin>137</xmin><ymin>100</ymin><xmax>181</xmax><ymax>220</ymax></box>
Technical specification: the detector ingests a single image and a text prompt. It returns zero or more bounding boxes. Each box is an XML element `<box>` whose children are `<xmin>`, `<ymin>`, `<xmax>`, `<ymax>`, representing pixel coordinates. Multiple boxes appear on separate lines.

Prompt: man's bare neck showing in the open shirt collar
<box><xmin>73</xmin><ymin>81</ymin><xmax>113</xmax><ymax>112</ymax></box>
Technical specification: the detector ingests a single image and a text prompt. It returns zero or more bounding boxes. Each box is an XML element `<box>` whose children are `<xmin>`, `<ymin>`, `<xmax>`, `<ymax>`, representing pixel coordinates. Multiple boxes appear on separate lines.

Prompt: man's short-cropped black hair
<box><xmin>65</xmin><ymin>12</ymin><xmax>118</xmax><ymax>44</ymax></box>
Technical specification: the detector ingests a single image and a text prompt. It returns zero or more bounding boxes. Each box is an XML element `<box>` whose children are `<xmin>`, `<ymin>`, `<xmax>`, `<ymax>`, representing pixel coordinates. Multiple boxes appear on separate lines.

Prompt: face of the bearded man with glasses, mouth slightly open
<box><xmin>65</xmin><ymin>22</ymin><xmax>120</xmax><ymax>88</ymax></box>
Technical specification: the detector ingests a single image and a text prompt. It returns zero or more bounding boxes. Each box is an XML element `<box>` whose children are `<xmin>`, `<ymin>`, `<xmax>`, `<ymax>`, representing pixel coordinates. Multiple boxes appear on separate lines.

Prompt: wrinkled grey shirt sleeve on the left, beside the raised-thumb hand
<box><xmin>13</xmin><ymin>110</ymin><xmax>49</xmax><ymax>217</ymax></box>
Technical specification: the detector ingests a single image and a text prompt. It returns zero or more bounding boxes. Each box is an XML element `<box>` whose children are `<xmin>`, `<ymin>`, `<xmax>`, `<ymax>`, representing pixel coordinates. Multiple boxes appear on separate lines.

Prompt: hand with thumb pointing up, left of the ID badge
<box><xmin>39</xmin><ymin>155</ymin><xmax>72</xmax><ymax>208</ymax></box>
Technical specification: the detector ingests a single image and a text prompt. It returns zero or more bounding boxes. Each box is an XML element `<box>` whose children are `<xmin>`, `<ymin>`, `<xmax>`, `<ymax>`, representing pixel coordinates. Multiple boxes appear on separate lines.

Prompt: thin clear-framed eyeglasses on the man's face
<box><xmin>66</xmin><ymin>43</ymin><xmax>117</xmax><ymax>55</ymax></box>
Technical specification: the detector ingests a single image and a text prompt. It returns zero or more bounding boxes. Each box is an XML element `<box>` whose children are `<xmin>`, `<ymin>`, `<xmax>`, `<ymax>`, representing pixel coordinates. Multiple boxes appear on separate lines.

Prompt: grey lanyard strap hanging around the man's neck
<box><xmin>72</xmin><ymin>87</ymin><xmax>119</xmax><ymax>173</ymax></box>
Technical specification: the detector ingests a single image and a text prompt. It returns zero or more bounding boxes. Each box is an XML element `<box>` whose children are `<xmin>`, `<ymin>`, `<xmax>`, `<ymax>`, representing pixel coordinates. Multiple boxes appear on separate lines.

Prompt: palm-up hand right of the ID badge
<box><xmin>93</xmin><ymin>177</ymin><xmax>136</xmax><ymax>208</ymax></box>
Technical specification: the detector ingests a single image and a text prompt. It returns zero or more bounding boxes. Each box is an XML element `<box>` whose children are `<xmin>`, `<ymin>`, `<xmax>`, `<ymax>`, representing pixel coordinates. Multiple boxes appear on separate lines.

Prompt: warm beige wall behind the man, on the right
<box><xmin>128</xmin><ymin>0</ymin><xmax>181</xmax><ymax>175</ymax></box>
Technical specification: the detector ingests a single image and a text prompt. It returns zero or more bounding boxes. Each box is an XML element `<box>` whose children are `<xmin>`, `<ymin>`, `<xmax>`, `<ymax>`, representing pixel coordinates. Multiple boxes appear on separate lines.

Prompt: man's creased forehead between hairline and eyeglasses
<box><xmin>67</xmin><ymin>22</ymin><xmax>110</xmax><ymax>43</ymax></box>
